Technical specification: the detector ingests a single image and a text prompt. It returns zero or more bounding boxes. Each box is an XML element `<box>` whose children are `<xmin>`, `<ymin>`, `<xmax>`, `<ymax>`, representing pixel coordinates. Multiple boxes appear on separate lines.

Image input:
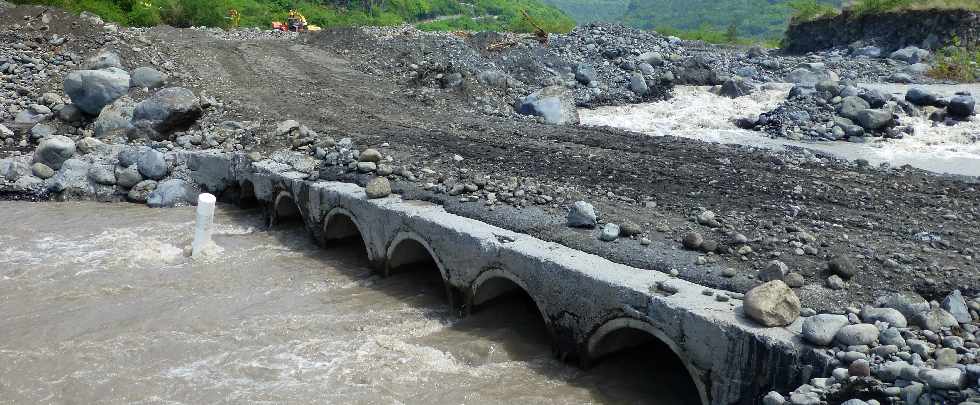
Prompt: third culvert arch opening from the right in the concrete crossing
<box><xmin>385</xmin><ymin>233</ymin><xmax>461</xmax><ymax>310</ymax></box>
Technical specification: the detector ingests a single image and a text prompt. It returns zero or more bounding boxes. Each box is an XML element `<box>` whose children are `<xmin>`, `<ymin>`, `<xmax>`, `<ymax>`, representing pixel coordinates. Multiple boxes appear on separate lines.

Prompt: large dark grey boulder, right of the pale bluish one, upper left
<box><xmin>133</xmin><ymin>87</ymin><xmax>204</xmax><ymax>136</ymax></box>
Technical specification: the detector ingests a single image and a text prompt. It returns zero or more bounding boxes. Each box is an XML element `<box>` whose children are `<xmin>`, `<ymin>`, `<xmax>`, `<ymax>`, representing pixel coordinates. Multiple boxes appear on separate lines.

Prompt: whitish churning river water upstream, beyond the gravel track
<box><xmin>579</xmin><ymin>86</ymin><xmax>980</xmax><ymax>176</ymax></box>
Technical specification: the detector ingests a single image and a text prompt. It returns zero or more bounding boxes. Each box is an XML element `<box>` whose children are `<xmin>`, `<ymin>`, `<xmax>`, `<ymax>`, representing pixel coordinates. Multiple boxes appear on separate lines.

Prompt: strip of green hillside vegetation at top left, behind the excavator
<box><xmin>13</xmin><ymin>0</ymin><xmax>575</xmax><ymax>31</ymax></box>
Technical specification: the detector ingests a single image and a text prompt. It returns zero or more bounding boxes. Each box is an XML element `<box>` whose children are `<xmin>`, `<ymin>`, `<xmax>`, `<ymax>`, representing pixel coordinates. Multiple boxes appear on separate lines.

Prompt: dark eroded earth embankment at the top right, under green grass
<box><xmin>784</xmin><ymin>10</ymin><xmax>980</xmax><ymax>53</ymax></box>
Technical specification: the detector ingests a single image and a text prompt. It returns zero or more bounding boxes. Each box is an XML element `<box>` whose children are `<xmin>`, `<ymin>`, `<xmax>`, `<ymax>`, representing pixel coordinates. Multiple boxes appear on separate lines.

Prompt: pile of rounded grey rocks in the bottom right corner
<box><xmin>763</xmin><ymin>290</ymin><xmax>980</xmax><ymax>405</ymax></box>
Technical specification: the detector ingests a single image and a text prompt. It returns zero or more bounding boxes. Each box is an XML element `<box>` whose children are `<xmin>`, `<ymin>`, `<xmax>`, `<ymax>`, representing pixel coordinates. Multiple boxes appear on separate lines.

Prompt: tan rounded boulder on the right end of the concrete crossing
<box><xmin>744</xmin><ymin>280</ymin><xmax>800</xmax><ymax>326</ymax></box>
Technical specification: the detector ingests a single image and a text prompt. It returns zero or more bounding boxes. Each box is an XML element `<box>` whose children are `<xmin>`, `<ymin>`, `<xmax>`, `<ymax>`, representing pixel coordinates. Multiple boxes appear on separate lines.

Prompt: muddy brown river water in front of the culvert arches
<box><xmin>0</xmin><ymin>202</ymin><xmax>696</xmax><ymax>404</ymax></box>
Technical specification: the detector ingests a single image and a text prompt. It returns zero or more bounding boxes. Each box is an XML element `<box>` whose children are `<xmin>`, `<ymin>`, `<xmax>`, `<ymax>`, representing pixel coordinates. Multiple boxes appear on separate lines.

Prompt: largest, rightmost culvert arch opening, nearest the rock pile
<box><xmin>587</xmin><ymin>318</ymin><xmax>709</xmax><ymax>405</ymax></box>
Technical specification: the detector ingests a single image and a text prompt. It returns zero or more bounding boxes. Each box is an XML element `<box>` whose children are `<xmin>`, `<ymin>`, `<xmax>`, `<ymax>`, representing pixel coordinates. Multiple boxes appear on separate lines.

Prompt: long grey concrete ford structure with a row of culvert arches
<box><xmin>182</xmin><ymin>153</ymin><xmax>831</xmax><ymax>404</ymax></box>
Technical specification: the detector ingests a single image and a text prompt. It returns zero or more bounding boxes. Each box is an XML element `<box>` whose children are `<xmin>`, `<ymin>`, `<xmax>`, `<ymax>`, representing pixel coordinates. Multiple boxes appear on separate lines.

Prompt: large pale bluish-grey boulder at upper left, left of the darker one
<box><xmin>65</xmin><ymin>68</ymin><xmax>129</xmax><ymax>115</ymax></box>
